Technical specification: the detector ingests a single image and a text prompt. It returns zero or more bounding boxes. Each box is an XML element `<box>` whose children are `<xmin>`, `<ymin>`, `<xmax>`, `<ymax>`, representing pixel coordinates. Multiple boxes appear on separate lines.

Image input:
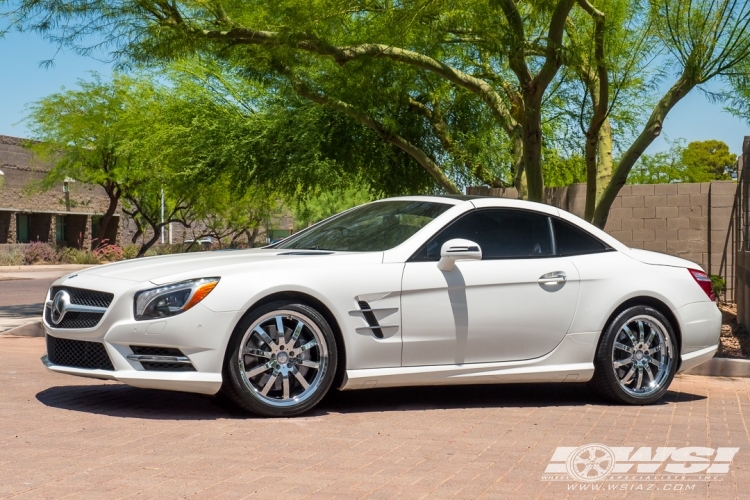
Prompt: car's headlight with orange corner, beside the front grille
<box><xmin>133</xmin><ymin>278</ymin><xmax>219</xmax><ymax>320</ymax></box>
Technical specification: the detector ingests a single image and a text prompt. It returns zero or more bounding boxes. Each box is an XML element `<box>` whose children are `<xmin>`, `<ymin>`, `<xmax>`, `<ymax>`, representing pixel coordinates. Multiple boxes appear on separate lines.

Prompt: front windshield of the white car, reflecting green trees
<box><xmin>275</xmin><ymin>201</ymin><xmax>452</xmax><ymax>252</ymax></box>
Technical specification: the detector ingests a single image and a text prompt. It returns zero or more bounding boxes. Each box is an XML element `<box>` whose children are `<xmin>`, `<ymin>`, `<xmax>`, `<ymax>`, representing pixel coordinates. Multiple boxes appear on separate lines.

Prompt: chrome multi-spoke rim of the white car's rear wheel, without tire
<box><xmin>612</xmin><ymin>315</ymin><xmax>674</xmax><ymax>398</ymax></box>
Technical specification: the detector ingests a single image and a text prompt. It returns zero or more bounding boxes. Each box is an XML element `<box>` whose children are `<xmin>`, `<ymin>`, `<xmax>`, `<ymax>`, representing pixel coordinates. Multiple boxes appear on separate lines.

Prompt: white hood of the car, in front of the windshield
<box><xmin>78</xmin><ymin>249</ymin><xmax>382</xmax><ymax>285</ymax></box>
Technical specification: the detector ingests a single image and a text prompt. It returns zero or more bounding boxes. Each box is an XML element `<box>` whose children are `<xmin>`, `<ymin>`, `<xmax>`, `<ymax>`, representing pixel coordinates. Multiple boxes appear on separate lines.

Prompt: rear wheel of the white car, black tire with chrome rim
<box><xmin>590</xmin><ymin>306</ymin><xmax>679</xmax><ymax>405</ymax></box>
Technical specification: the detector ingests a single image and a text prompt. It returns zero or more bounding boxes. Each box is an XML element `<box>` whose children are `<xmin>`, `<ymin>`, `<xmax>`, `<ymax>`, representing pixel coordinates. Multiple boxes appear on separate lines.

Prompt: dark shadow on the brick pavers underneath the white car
<box><xmin>36</xmin><ymin>384</ymin><xmax>706</xmax><ymax>420</ymax></box>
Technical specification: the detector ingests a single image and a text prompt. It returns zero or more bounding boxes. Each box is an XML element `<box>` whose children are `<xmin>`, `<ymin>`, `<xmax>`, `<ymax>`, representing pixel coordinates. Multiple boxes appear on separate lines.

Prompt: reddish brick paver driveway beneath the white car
<box><xmin>0</xmin><ymin>337</ymin><xmax>750</xmax><ymax>499</ymax></box>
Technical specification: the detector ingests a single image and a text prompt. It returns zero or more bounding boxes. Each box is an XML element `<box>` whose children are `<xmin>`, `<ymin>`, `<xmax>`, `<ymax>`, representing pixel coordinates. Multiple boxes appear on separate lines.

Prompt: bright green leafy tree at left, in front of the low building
<box><xmin>30</xmin><ymin>75</ymin><xmax>284</xmax><ymax>257</ymax></box>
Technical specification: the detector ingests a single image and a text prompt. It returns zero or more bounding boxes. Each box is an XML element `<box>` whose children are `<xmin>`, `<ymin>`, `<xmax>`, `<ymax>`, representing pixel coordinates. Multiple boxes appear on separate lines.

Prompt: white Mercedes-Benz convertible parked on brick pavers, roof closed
<box><xmin>42</xmin><ymin>196</ymin><xmax>721</xmax><ymax>416</ymax></box>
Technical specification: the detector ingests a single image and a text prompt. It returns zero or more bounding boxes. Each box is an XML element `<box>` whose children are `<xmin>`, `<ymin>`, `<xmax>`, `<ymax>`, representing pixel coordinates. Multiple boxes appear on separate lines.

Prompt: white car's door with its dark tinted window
<box><xmin>401</xmin><ymin>208</ymin><xmax>579</xmax><ymax>366</ymax></box>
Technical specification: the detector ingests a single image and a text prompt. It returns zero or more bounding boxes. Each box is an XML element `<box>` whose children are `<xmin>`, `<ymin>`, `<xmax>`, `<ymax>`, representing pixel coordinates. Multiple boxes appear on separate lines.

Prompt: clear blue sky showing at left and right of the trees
<box><xmin>0</xmin><ymin>33</ymin><xmax>750</xmax><ymax>154</ymax></box>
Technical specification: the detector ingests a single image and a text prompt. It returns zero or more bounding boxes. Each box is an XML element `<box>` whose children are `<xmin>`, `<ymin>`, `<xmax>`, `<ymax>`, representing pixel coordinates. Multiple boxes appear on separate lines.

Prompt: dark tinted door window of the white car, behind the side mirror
<box><xmin>411</xmin><ymin>209</ymin><xmax>552</xmax><ymax>261</ymax></box>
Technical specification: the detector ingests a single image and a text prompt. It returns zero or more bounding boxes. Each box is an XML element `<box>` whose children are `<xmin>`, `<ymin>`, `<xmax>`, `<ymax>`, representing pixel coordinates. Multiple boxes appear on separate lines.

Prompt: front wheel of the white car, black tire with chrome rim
<box><xmin>222</xmin><ymin>301</ymin><xmax>338</xmax><ymax>417</ymax></box>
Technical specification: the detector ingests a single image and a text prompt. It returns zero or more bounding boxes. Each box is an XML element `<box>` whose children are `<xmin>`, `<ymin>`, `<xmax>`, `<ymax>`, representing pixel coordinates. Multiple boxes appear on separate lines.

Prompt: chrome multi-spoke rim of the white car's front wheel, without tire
<box><xmin>237</xmin><ymin>310</ymin><xmax>328</xmax><ymax>408</ymax></box>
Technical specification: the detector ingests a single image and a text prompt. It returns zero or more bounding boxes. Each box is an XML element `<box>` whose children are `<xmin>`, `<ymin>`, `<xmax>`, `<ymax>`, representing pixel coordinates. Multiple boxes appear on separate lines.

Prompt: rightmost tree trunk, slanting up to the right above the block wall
<box><xmin>592</xmin><ymin>75</ymin><xmax>697</xmax><ymax>229</ymax></box>
